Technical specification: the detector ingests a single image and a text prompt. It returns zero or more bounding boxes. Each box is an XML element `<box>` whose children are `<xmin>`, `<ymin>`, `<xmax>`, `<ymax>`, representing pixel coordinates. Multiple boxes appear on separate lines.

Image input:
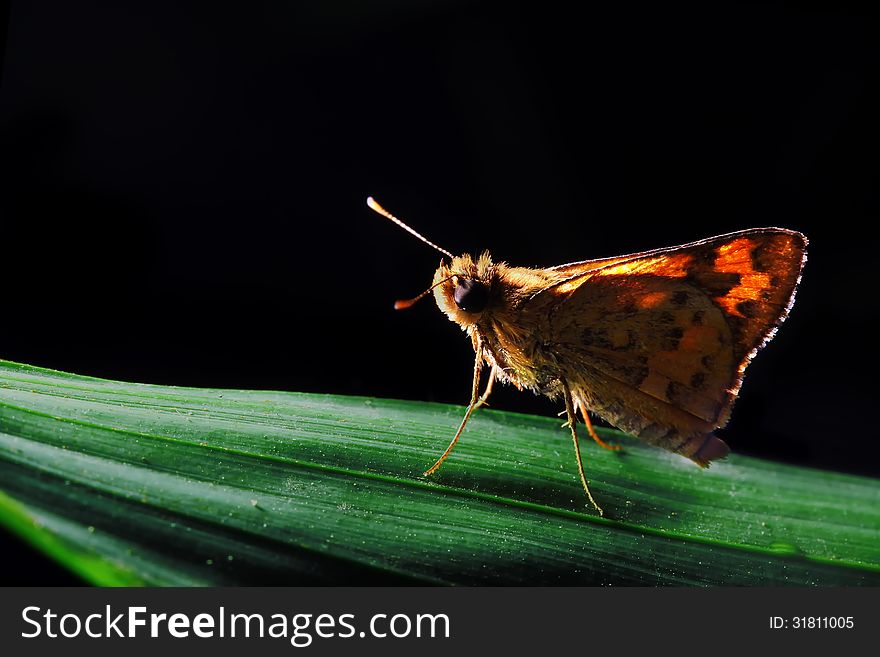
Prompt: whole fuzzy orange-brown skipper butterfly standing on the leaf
<box><xmin>367</xmin><ymin>198</ymin><xmax>807</xmax><ymax>514</ymax></box>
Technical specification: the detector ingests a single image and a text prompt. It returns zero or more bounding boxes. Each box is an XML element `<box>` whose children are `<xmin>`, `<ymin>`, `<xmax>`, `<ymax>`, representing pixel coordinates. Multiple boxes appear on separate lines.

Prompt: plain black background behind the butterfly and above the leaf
<box><xmin>0</xmin><ymin>0</ymin><xmax>880</xmax><ymax>580</ymax></box>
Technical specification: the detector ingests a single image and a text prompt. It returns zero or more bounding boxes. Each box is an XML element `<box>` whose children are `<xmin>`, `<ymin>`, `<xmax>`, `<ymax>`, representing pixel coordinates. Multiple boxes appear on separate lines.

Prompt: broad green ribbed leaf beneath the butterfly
<box><xmin>0</xmin><ymin>361</ymin><xmax>880</xmax><ymax>586</ymax></box>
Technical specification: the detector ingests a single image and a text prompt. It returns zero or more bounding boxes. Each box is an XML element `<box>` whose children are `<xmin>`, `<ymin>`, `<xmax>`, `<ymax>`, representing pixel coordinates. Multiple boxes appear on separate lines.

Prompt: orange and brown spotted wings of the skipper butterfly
<box><xmin>536</xmin><ymin>228</ymin><xmax>806</xmax><ymax>458</ymax></box>
